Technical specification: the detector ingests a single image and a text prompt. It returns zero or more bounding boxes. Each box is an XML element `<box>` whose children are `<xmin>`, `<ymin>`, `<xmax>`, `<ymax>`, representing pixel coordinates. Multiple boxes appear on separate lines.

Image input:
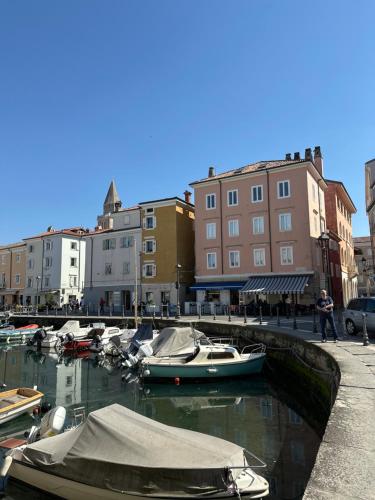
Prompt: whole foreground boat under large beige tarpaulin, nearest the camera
<box><xmin>2</xmin><ymin>404</ymin><xmax>269</xmax><ymax>500</ymax></box>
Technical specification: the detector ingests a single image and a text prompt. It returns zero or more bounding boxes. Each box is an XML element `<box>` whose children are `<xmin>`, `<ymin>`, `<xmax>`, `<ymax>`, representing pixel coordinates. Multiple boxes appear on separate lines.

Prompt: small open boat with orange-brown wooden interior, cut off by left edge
<box><xmin>0</xmin><ymin>387</ymin><xmax>44</xmax><ymax>424</ymax></box>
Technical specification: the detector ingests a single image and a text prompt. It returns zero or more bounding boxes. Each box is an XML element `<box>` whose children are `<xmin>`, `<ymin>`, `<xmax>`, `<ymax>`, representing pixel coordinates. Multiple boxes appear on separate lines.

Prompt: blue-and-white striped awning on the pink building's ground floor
<box><xmin>244</xmin><ymin>274</ymin><xmax>311</xmax><ymax>294</ymax></box>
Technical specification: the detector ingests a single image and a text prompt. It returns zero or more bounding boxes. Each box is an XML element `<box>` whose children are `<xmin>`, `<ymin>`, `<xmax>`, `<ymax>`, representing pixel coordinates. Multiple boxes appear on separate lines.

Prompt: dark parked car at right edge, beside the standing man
<box><xmin>343</xmin><ymin>297</ymin><xmax>375</xmax><ymax>336</ymax></box>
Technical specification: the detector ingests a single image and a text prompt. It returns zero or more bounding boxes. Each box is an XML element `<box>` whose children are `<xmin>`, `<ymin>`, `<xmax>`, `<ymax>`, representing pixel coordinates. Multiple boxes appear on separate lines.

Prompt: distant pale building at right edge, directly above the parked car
<box><xmin>353</xmin><ymin>236</ymin><xmax>375</xmax><ymax>297</ymax></box>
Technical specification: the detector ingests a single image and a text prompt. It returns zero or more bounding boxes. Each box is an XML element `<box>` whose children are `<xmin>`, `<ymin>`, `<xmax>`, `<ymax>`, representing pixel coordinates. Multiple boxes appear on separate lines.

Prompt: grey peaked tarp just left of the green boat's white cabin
<box><xmin>151</xmin><ymin>326</ymin><xmax>206</xmax><ymax>358</ymax></box>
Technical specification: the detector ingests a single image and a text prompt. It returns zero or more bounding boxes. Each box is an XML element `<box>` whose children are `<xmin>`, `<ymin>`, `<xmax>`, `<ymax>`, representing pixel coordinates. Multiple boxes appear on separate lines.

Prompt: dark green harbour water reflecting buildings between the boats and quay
<box><xmin>0</xmin><ymin>346</ymin><xmax>321</xmax><ymax>500</ymax></box>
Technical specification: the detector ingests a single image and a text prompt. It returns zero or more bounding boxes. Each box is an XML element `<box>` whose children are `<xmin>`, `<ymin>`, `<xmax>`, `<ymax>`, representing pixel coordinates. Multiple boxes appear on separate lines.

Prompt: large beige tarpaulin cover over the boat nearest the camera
<box><xmin>23</xmin><ymin>404</ymin><xmax>246</xmax><ymax>499</ymax></box>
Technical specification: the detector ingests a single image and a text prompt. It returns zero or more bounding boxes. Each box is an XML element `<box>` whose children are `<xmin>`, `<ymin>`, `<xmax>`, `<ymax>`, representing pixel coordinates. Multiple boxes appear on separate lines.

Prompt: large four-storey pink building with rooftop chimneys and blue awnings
<box><xmin>191</xmin><ymin>146</ymin><xmax>327</xmax><ymax>305</ymax></box>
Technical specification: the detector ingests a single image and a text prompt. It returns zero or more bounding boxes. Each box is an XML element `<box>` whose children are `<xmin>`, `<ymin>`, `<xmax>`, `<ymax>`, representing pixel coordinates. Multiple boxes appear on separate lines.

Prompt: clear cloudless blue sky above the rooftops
<box><xmin>0</xmin><ymin>0</ymin><xmax>375</xmax><ymax>244</ymax></box>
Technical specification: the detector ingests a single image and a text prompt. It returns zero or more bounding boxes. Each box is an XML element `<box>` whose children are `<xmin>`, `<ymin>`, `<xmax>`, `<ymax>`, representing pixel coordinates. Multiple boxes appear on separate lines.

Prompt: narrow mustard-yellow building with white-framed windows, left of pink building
<box><xmin>139</xmin><ymin>191</ymin><xmax>195</xmax><ymax>312</ymax></box>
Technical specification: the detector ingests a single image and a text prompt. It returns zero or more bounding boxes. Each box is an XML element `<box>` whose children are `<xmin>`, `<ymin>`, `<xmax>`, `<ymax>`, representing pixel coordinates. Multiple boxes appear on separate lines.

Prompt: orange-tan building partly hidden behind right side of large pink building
<box><xmin>324</xmin><ymin>179</ymin><xmax>358</xmax><ymax>306</ymax></box>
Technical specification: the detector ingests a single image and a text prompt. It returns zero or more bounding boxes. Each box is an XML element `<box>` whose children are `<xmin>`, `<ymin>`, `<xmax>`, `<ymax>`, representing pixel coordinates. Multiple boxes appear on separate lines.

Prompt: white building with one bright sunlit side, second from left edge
<box><xmin>24</xmin><ymin>228</ymin><xmax>86</xmax><ymax>306</ymax></box>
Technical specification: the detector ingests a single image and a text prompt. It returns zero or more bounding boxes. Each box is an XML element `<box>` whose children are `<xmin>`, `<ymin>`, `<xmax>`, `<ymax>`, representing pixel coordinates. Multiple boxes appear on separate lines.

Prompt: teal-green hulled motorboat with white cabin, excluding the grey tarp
<box><xmin>141</xmin><ymin>344</ymin><xmax>266</xmax><ymax>379</ymax></box>
